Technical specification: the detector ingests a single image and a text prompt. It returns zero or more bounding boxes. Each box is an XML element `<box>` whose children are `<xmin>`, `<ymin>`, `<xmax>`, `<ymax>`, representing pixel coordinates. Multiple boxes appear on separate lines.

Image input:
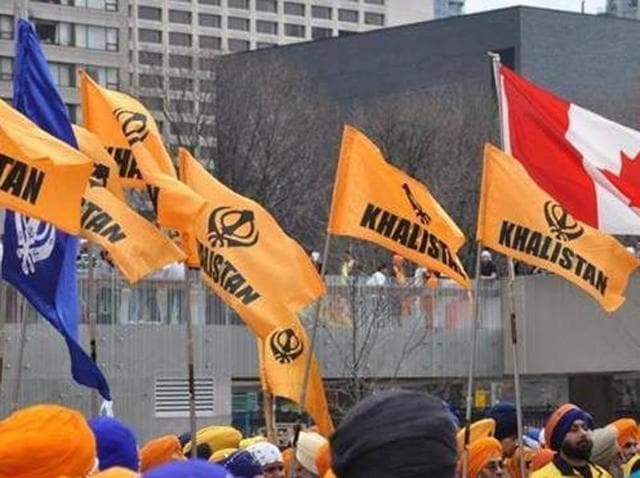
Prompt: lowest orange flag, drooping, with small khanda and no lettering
<box><xmin>261</xmin><ymin>318</ymin><xmax>333</xmax><ymax>437</ymax></box>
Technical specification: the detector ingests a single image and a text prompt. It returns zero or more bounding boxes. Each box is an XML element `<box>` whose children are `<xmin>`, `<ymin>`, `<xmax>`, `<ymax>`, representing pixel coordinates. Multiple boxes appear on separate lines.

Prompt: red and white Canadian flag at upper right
<box><xmin>499</xmin><ymin>66</ymin><xmax>640</xmax><ymax>234</ymax></box>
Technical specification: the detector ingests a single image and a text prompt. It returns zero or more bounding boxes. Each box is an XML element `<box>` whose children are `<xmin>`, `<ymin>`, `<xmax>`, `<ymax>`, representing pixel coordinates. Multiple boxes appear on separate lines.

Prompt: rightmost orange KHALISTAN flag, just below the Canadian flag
<box><xmin>477</xmin><ymin>144</ymin><xmax>640</xmax><ymax>312</ymax></box>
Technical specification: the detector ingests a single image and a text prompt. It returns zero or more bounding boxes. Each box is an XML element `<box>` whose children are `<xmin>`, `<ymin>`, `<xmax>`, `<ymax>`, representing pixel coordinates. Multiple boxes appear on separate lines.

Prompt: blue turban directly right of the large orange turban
<box><xmin>89</xmin><ymin>417</ymin><xmax>140</xmax><ymax>471</ymax></box>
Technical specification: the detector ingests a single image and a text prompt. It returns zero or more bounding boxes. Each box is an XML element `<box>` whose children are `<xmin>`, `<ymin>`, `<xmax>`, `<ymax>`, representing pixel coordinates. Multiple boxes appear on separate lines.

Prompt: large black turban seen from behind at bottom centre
<box><xmin>330</xmin><ymin>390</ymin><xmax>457</xmax><ymax>478</ymax></box>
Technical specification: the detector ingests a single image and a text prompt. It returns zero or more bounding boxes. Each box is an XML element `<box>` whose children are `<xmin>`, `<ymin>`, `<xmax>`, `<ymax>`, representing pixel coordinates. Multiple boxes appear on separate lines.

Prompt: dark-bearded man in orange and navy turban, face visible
<box><xmin>531</xmin><ymin>403</ymin><xmax>611</xmax><ymax>478</ymax></box>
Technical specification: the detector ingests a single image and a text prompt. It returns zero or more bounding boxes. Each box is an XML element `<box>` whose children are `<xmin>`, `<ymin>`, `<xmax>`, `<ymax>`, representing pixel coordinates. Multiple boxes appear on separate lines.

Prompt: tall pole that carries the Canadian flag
<box><xmin>488</xmin><ymin>52</ymin><xmax>526</xmax><ymax>478</ymax></box>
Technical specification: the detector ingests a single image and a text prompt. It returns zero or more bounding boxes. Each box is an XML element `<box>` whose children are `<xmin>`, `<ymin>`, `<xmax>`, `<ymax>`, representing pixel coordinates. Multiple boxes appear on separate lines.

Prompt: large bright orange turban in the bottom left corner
<box><xmin>0</xmin><ymin>405</ymin><xmax>96</xmax><ymax>478</ymax></box>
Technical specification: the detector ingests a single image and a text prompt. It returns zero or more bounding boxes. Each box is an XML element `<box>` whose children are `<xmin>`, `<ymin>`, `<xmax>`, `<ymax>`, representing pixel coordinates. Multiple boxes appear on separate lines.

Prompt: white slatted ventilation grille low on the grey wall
<box><xmin>155</xmin><ymin>378</ymin><xmax>215</xmax><ymax>418</ymax></box>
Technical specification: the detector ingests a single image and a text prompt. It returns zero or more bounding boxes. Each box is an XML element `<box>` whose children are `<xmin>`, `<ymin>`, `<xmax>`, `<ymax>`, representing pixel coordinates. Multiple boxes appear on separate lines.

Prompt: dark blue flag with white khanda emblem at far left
<box><xmin>2</xmin><ymin>19</ymin><xmax>111</xmax><ymax>401</ymax></box>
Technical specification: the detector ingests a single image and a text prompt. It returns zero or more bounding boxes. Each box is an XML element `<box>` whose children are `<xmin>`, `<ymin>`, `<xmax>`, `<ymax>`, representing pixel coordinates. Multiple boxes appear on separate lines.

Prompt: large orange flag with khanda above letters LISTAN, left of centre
<box><xmin>180</xmin><ymin>149</ymin><xmax>326</xmax><ymax>338</ymax></box>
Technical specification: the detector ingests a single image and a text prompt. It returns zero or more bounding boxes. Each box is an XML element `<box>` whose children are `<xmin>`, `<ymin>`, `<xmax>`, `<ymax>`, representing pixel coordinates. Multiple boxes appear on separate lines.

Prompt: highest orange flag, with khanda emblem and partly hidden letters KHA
<box><xmin>80</xmin><ymin>71</ymin><xmax>176</xmax><ymax>188</ymax></box>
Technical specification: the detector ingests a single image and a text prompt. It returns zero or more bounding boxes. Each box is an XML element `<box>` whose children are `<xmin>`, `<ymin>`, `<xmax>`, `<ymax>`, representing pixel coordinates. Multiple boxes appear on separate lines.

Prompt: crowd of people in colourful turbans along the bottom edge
<box><xmin>0</xmin><ymin>390</ymin><xmax>640</xmax><ymax>478</ymax></box>
